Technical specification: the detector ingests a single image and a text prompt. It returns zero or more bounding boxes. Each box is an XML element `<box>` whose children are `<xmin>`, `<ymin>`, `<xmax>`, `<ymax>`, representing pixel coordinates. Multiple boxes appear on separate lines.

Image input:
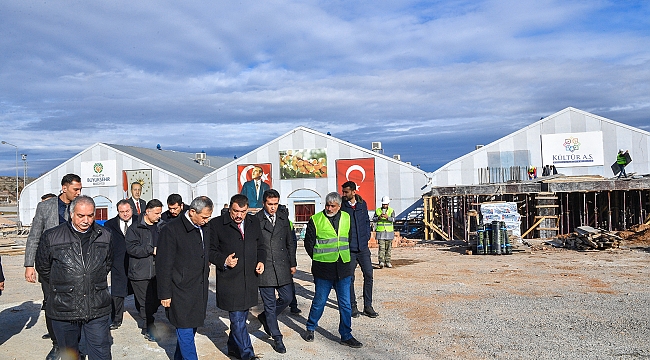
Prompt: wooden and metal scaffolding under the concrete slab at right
<box><xmin>423</xmin><ymin>175</ymin><xmax>650</xmax><ymax>241</ymax></box>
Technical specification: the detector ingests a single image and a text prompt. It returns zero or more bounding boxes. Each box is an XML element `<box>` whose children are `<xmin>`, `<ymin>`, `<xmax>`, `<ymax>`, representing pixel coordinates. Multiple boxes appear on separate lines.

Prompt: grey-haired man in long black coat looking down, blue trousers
<box><xmin>156</xmin><ymin>196</ymin><xmax>214</xmax><ymax>359</ymax></box>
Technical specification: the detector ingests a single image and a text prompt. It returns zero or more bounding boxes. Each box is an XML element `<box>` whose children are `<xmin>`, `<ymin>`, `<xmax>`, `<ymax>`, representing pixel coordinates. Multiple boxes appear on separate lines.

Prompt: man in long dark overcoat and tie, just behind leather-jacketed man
<box><xmin>104</xmin><ymin>199</ymin><xmax>133</xmax><ymax>330</ymax></box>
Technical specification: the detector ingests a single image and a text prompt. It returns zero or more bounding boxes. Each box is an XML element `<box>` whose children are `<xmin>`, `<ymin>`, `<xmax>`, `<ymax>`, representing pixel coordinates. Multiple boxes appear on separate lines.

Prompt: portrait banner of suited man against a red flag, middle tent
<box><xmin>237</xmin><ymin>164</ymin><xmax>273</xmax><ymax>208</ymax></box>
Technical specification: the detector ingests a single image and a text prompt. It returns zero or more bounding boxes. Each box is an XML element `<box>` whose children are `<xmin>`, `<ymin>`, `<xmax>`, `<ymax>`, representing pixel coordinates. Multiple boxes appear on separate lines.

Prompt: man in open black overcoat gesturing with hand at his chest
<box><xmin>210</xmin><ymin>194</ymin><xmax>266</xmax><ymax>360</ymax></box>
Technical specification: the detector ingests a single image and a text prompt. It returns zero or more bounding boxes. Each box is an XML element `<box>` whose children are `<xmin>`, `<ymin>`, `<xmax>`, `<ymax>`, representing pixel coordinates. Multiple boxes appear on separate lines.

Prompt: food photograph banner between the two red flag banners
<box><xmin>280</xmin><ymin>149</ymin><xmax>327</xmax><ymax>180</ymax></box>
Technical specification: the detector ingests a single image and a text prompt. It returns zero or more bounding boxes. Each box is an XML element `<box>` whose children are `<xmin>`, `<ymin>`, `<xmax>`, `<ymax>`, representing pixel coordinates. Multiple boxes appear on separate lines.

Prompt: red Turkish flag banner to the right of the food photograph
<box><xmin>336</xmin><ymin>158</ymin><xmax>376</xmax><ymax>210</ymax></box>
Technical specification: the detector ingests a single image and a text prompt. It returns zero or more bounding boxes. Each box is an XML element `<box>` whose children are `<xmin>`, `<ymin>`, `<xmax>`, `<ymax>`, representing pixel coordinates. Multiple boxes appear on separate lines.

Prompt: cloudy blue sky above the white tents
<box><xmin>0</xmin><ymin>0</ymin><xmax>650</xmax><ymax>176</ymax></box>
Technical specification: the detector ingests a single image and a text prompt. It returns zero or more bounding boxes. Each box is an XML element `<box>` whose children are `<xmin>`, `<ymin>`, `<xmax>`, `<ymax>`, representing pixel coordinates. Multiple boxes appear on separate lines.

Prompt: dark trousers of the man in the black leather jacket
<box><xmin>52</xmin><ymin>315</ymin><xmax>111</xmax><ymax>360</ymax></box>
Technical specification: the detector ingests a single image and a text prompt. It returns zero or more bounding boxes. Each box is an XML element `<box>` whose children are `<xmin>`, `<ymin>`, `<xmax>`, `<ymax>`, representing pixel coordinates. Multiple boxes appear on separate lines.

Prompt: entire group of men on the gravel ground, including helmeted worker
<box><xmin>25</xmin><ymin>174</ymin><xmax>394</xmax><ymax>359</ymax></box>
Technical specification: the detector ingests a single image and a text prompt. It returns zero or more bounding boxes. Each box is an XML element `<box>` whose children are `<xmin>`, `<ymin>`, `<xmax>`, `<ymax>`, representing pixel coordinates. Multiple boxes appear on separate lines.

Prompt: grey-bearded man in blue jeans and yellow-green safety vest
<box><xmin>304</xmin><ymin>192</ymin><xmax>363</xmax><ymax>348</ymax></box>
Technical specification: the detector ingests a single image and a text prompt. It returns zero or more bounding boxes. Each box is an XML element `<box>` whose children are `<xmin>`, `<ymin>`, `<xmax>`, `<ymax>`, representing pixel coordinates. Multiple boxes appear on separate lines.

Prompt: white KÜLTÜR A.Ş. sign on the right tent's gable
<box><xmin>542</xmin><ymin>131</ymin><xmax>604</xmax><ymax>168</ymax></box>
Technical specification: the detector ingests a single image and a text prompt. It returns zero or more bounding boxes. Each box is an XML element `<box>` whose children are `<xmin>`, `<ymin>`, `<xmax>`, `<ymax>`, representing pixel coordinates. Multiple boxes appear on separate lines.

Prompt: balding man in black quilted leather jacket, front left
<box><xmin>35</xmin><ymin>195</ymin><xmax>113</xmax><ymax>360</ymax></box>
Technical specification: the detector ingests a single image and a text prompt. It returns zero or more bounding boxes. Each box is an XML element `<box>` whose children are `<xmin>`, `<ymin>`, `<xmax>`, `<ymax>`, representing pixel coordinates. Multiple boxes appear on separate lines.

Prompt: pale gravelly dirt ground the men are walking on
<box><xmin>0</xmin><ymin>242</ymin><xmax>650</xmax><ymax>359</ymax></box>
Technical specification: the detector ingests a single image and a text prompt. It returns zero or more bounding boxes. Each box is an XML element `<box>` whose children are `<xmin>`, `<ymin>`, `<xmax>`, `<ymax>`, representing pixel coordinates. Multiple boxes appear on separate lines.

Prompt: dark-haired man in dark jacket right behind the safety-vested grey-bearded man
<box><xmin>341</xmin><ymin>181</ymin><xmax>379</xmax><ymax>318</ymax></box>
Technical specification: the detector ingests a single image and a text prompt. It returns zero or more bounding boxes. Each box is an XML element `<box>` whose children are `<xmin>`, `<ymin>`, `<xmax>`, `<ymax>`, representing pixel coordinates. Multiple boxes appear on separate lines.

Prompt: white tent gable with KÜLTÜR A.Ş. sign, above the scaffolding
<box><xmin>429</xmin><ymin>107</ymin><xmax>650</xmax><ymax>186</ymax></box>
